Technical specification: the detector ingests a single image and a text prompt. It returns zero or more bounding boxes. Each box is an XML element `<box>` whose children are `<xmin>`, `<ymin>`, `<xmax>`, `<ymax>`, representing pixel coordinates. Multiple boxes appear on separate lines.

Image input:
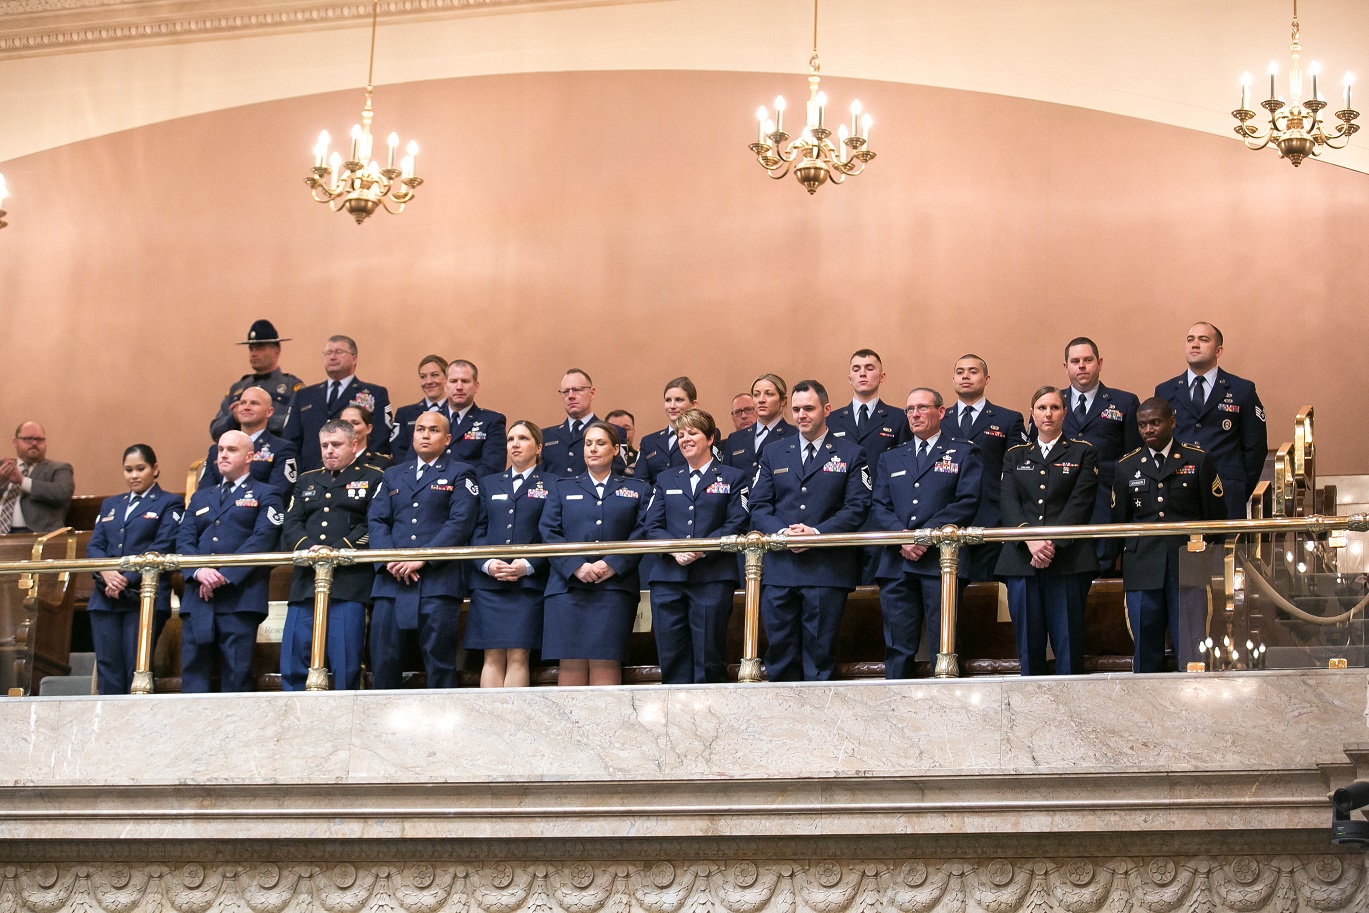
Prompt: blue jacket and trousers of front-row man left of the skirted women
<box><xmin>367</xmin><ymin>456</ymin><xmax>481</xmax><ymax>689</ymax></box>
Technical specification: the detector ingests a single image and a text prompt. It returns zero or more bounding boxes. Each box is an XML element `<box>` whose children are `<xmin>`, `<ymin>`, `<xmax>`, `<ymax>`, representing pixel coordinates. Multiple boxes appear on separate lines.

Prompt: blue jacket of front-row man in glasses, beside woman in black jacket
<box><xmin>870</xmin><ymin>438</ymin><xmax>984</xmax><ymax>580</ymax></box>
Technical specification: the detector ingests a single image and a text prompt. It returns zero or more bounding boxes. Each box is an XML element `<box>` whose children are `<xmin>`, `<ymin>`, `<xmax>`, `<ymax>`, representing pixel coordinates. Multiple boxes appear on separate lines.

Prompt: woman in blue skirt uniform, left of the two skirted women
<box><xmin>465</xmin><ymin>420</ymin><xmax>550</xmax><ymax>689</ymax></box>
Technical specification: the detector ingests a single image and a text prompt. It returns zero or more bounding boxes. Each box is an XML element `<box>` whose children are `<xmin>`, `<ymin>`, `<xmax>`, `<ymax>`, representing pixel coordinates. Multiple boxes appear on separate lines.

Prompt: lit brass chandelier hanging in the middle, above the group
<box><xmin>750</xmin><ymin>0</ymin><xmax>875</xmax><ymax>193</ymax></box>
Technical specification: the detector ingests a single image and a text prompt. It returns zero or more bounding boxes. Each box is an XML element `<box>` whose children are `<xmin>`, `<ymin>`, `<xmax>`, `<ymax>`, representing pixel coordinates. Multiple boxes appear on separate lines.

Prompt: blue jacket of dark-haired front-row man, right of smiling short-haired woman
<box><xmin>750</xmin><ymin>434</ymin><xmax>872</xmax><ymax>590</ymax></box>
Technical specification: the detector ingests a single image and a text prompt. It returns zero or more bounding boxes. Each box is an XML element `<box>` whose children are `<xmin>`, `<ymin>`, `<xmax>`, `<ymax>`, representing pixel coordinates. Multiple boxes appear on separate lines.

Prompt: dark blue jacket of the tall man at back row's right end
<box><xmin>1155</xmin><ymin>368</ymin><xmax>1269</xmax><ymax>520</ymax></box>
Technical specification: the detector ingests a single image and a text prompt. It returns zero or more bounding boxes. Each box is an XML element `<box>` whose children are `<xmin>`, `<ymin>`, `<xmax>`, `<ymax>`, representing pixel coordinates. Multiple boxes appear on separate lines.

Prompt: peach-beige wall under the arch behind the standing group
<box><xmin>0</xmin><ymin>71</ymin><xmax>1369</xmax><ymax>493</ymax></box>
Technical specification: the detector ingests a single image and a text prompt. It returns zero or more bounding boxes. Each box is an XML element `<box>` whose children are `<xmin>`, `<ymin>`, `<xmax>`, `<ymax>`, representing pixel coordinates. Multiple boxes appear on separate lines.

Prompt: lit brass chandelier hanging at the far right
<box><xmin>1231</xmin><ymin>0</ymin><xmax>1359</xmax><ymax>167</ymax></box>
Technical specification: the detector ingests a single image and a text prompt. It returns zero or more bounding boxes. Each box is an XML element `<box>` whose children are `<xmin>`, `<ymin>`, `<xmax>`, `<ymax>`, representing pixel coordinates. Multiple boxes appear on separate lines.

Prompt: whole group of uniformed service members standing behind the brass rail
<box><xmin>88</xmin><ymin>320</ymin><xmax>1268</xmax><ymax>693</ymax></box>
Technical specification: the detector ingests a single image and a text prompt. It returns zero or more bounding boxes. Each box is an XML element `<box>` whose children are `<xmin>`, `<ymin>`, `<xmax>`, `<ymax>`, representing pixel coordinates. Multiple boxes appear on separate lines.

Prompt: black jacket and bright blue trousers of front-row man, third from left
<box><xmin>281</xmin><ymin>456</ymin><xmax>385</xmax><ymax>691</ymax></box>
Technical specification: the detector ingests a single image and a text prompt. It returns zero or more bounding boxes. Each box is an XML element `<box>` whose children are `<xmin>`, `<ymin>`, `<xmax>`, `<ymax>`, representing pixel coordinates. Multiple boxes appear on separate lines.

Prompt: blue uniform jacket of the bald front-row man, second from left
<box><xmin>175</xmin><ymin>478</ymin><xmax>285</xmax><ymax>617</ymax></box>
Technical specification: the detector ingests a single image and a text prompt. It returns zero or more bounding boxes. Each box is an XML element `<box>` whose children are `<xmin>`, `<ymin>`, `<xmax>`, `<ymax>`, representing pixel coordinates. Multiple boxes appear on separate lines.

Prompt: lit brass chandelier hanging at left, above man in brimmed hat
<box><xmin>304</xmin><ymin>0</ymin><xmax>423</xmax><ymax>224</ymax></box>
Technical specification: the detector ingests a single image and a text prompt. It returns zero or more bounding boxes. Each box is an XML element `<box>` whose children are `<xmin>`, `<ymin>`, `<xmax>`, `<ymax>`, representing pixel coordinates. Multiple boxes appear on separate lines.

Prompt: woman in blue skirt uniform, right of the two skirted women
<box><xmin>541</xmin><ymin>422</ymin><xmax>652</xmax><ymax>684</ymax></box>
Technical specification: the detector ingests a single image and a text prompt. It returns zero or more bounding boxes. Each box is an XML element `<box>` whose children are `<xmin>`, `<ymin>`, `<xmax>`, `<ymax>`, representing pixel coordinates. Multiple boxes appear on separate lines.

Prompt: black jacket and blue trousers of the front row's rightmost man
<box><xmin>1112</xmin><ymin>439</ymin><xmax>1228</xmax><ymax>672</ymax></box>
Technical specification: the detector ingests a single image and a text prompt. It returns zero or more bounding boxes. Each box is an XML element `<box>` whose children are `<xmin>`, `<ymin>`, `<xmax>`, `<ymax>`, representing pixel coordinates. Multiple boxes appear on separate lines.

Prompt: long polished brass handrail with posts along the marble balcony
<box><xmin>0</xmin><ymin>513</ymin><xmax>1369</xmax><ymax>694</ymax></box>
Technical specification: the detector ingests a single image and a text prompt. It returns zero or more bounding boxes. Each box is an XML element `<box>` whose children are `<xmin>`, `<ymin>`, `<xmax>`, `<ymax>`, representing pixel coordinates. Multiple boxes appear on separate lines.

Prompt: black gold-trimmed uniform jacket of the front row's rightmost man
<box><xmin>1112</xmin><ymin>441</ymin><xmax>1227</xmax><ymax>590</ymax></box>
